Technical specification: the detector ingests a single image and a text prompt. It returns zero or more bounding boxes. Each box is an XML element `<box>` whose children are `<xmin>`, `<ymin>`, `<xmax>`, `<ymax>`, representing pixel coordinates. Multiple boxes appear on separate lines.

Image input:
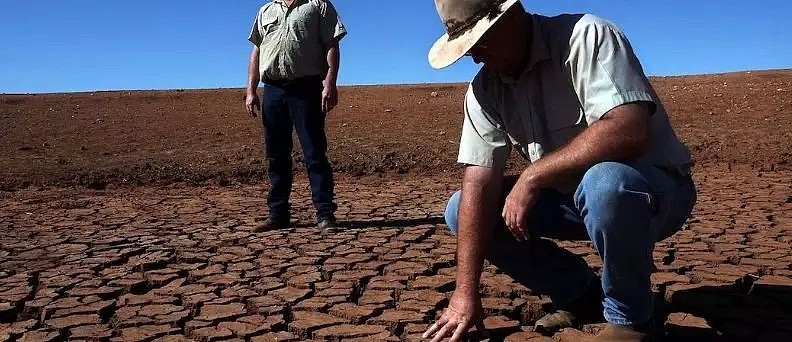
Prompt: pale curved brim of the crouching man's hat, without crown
<box><xmin>429</xmin><ymin>0</ymin><xmax>520</xmax><ymax>69</ymax></box>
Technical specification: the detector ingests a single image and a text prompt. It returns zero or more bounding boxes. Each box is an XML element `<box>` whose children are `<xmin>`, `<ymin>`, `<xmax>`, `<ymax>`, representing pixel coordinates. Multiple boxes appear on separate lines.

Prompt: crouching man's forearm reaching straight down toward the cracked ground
<box><xmin>456</xmin><ymin>166</ymin><xmax>503</xmax><ymax>295</ymax></box>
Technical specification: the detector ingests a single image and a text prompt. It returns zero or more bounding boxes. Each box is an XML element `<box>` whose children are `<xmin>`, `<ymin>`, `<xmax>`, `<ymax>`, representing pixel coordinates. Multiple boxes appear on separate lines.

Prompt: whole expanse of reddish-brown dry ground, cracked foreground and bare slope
<box><xmin>0</xmin><ymin>71</ymin><xmax>792</xmax><ymax>341</ymax></box>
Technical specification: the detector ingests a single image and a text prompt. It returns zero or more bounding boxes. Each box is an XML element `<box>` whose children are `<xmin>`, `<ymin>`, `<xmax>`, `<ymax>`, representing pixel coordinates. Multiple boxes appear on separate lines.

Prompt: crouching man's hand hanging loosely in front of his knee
<box><xmin>502</xmin><ymin>173</ymin><xmax>540</xmax><ymax>241</ymax></box>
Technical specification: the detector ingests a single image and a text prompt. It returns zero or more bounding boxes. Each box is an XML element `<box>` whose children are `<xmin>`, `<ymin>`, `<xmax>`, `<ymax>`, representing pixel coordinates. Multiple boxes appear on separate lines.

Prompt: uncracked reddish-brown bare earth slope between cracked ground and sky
<box><xmin>0</xmin><ymin>70</ymin><xmax>792</xmax><ymax>190</ymax></box>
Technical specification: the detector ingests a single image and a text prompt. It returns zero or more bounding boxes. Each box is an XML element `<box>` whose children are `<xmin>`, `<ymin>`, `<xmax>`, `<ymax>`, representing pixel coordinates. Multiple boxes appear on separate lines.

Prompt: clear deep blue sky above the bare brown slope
<box><xmin>0</xmin><ymin>0</ymin><xmax>792</xmax><ymax>93</ymax></box>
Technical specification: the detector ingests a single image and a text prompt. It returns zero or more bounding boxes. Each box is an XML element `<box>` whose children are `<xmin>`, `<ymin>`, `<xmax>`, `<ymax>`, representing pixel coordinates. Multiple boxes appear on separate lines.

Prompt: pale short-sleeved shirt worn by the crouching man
<box><xmin>458</xmin><ymin>14</ymin><xmax>691</xmax><ymax>174</ymax></box>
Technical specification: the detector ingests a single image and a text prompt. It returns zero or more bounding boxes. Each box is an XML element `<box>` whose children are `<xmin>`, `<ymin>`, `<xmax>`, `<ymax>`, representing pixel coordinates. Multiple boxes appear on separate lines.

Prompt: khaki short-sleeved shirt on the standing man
<box><xmin>248</xmin><ymin>0</ymin><xmax>347</xmax><ymax>81</ymax></box>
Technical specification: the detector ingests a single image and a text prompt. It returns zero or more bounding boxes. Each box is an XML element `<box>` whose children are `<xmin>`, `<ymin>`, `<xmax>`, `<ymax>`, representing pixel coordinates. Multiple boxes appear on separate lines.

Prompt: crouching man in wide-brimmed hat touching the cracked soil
<box><xmin>424</xmin><ymin>0</ymin><xmax>696</xmax><ymax>341</ymax></box>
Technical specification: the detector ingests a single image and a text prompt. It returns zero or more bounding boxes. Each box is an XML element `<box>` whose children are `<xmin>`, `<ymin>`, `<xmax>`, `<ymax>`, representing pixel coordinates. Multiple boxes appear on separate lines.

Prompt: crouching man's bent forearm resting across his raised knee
<box><xmin>523</xmin><ymin>103</ymin><xmax>651</xmax><ymax>188</ymax></box>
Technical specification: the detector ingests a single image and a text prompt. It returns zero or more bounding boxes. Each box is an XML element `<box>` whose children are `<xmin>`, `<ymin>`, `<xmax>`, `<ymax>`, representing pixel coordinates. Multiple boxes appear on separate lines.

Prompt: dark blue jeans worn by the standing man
<box><xmin>261</xmin><ymin>77</ymin><xmax>335</xmax><ymax>221</ymax></box>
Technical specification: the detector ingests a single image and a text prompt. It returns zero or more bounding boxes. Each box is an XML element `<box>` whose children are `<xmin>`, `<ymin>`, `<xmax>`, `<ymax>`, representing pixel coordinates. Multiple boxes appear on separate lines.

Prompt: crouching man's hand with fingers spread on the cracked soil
<box><xmin>422</xmin><ymin>291</ymin><xmax>485</xmax><ymax>342</ymax></box>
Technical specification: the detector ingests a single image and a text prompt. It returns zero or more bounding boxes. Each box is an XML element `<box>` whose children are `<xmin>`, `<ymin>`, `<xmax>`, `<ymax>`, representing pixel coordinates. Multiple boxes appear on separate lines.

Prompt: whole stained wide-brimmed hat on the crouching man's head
<box><xmin>429</xmin><ymin>0</ymin><xmax>519</xmax><ymax>69</ymax></box>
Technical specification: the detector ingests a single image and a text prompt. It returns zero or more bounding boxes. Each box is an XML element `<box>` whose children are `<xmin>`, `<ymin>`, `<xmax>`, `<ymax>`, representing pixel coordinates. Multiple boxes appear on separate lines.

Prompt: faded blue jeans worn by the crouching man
<box><xmin>445</xmin><ymin>162</ymin><xmax>696</xmax><ymax>325</ymax></box>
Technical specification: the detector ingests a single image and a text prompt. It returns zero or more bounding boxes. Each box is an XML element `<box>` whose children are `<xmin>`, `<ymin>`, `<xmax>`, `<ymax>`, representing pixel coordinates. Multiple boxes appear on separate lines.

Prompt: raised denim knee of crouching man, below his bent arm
<box><xmin>575</xmin><ymin>162</ymin><xmax>652</xmax><ymax>211</ymax></box>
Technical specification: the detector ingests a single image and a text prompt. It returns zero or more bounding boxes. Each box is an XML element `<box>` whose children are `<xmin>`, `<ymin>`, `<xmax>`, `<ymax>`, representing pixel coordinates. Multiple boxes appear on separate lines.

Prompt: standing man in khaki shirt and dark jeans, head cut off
<box><xmin>245</xmin><ymin>0</ymin><xmax>346</xmax><ymax>231</ymax></box>
